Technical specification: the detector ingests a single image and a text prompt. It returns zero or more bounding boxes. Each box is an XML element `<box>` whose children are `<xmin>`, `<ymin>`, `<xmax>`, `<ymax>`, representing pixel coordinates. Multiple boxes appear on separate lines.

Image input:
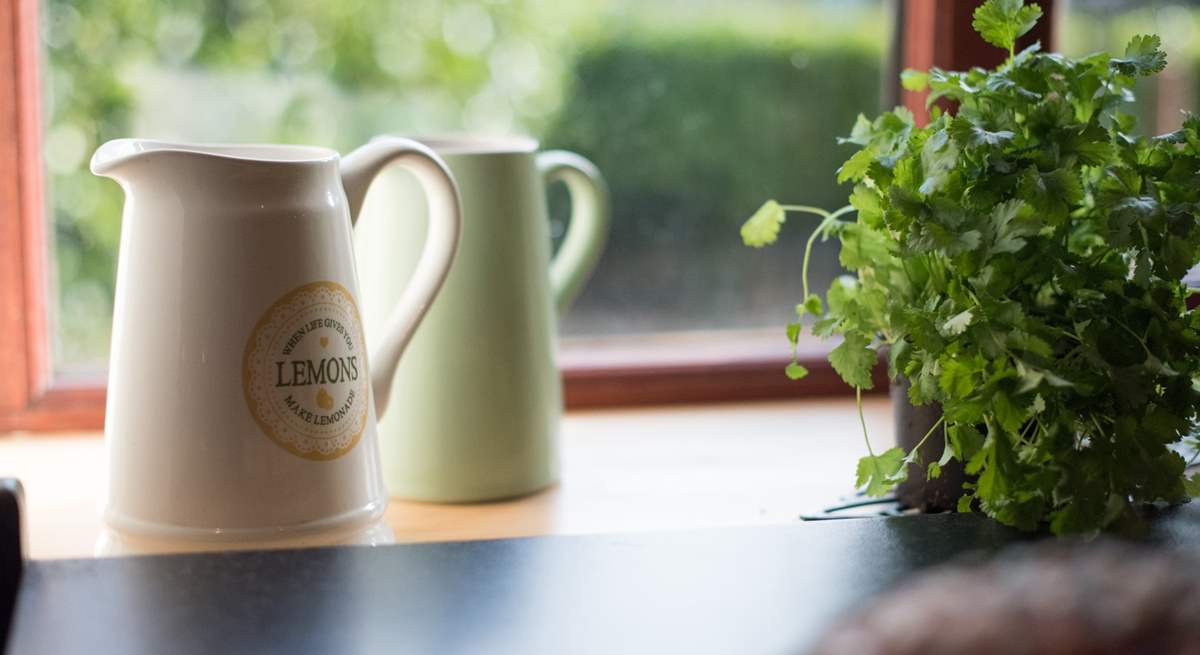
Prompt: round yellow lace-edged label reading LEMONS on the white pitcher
<box><xmin>242</xmin><ymin>282</ymin><xmax>371</xmax><ymax>461</ymax></box>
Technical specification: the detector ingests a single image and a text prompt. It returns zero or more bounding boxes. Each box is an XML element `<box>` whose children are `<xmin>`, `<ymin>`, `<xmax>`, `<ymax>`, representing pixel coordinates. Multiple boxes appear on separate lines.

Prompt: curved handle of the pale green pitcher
<box><xmin>538</xmin><ymin>150</ymin><xmax>610</xmax><ymax>316</ymax></box>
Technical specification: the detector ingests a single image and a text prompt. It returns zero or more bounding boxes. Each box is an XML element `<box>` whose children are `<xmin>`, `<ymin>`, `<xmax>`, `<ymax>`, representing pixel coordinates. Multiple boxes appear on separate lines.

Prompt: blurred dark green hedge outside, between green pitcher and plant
<box><xmin>544</xmin><ymin>36</ymin><xmax>881</xmax><ymax>335</ymax></box>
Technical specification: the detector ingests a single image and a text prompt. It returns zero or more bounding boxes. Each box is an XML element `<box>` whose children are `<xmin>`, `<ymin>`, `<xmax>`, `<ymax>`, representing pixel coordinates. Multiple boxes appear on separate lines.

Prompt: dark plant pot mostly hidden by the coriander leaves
<box><xmin>890</xmin><ymin>377</ymin><xmax>967</xmax><ymax>512</ymax></box>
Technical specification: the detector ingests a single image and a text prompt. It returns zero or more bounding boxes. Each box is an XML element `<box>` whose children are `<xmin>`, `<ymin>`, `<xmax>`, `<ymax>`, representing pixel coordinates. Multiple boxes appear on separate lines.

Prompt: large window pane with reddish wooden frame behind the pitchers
<box><xmin>0</xmin><ymin>0</ymin><xmax>1051</xmax><ymax>427</ymax></box>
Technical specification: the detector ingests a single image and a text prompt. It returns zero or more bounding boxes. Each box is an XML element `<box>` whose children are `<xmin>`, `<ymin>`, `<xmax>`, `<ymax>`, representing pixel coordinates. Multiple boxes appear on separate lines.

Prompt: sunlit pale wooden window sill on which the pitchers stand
<box><xmin>0</xmin><ymin>397</ymin><xmax>893</xmax><ymax>559</ymax></box>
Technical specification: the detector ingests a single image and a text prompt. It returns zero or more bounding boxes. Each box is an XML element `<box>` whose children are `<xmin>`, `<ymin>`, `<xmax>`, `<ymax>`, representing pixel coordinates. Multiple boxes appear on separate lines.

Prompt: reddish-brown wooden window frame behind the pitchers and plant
<box><xmin>0</xmin><ymin>0</ymin><xmax>1054</xmax><ymax>432</ymax></box>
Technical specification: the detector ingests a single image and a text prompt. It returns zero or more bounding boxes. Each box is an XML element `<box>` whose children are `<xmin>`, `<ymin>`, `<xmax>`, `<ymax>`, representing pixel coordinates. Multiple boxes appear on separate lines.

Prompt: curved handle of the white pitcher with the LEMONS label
<box><xmin>342</xmin><ymin>137</ymin><xmax>462</xmax><ymax>417</ymax></box>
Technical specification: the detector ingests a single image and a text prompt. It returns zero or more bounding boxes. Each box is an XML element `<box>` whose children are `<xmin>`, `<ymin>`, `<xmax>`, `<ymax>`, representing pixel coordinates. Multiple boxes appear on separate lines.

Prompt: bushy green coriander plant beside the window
<box><xmin>742</xmin><ymin>0</ymin><xmax>1200</xmax><ymax>534</ymax></box>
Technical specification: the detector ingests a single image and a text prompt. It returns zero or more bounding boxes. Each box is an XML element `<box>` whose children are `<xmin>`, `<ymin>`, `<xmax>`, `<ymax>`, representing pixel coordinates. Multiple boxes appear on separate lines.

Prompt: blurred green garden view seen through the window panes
<box><xmin>42</xmin><ymin>0</ymin><xmax>1196</xmax><ymax>371</ymax></box>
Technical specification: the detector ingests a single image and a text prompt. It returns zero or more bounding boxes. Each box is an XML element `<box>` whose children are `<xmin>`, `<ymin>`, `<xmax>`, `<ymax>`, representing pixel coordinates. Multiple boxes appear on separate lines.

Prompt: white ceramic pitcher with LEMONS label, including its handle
<box><xmin>91</xmin><ymin>139</ymin><xmax>460</xmax><ymax>541</ymax></box>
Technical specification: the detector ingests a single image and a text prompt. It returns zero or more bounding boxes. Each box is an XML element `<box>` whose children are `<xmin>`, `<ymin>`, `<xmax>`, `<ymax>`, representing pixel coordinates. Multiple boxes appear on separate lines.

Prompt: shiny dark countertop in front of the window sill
<box><xmin>8</xmin><ymin>505</ymin><xmax>1200</xmax><ymax>654</ymax></box>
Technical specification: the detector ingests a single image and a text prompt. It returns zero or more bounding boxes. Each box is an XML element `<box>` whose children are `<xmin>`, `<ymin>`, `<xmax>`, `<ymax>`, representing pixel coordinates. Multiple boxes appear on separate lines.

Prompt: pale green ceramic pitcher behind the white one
<box><xmin>355</xmin><ymin>138</ymin><xmax>608</xmax><ymax>503</ymax></box>
